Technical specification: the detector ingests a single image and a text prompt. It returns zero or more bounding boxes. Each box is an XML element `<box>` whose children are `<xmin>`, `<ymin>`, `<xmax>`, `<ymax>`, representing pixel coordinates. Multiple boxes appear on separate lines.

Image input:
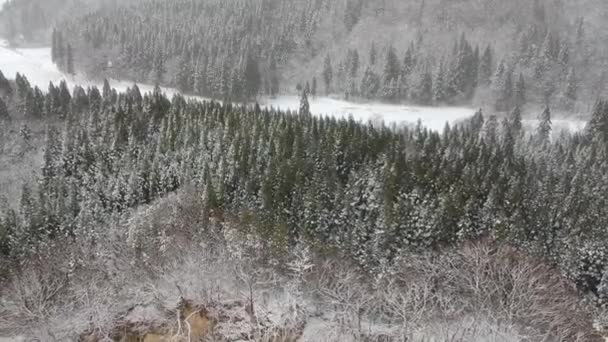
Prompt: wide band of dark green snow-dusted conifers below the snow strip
<box><xmin>0</xmin><ymin>72</ymin><xmax>608</xmax><ymax>300</ymax></box>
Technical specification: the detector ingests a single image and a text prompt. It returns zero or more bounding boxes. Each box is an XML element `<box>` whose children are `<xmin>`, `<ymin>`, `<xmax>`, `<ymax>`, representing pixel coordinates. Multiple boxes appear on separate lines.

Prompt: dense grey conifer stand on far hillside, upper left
<box><xmin>58</xmin><ymin>0</ymin><xmax>350</xmax><ymax>100</ymax></box>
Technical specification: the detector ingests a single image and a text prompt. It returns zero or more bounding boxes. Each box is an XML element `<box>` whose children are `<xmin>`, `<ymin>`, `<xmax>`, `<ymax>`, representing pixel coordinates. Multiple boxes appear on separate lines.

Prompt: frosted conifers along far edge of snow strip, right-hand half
<box><xmin>324</xmin><ymin>24</ymin><xmax>580</xmax><ymax>111</ymax></box>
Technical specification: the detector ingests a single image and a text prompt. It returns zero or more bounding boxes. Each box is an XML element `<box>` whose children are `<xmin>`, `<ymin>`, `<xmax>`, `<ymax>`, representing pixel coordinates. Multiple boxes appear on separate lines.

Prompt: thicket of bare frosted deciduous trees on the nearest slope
<box><xmin>0</xmin><ymin>191</ymin><xmax>597</xmax><ymax>342</ymax></box>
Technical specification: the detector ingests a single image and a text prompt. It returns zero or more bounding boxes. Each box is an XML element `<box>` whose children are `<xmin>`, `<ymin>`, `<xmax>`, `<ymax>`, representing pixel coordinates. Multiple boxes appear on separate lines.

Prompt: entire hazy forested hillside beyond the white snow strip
<box><xmin>53</xmin><ymin>0</ymin><xmax>607</xmax><ymax>112</ymax></box>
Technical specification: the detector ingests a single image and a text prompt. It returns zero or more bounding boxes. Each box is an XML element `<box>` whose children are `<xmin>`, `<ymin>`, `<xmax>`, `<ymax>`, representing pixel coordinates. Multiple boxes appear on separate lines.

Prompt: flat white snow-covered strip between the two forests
<box><xmin>0</xmin><ymin>38</ymin><xmax>585</xmax><ymax>132</ymax></box>
